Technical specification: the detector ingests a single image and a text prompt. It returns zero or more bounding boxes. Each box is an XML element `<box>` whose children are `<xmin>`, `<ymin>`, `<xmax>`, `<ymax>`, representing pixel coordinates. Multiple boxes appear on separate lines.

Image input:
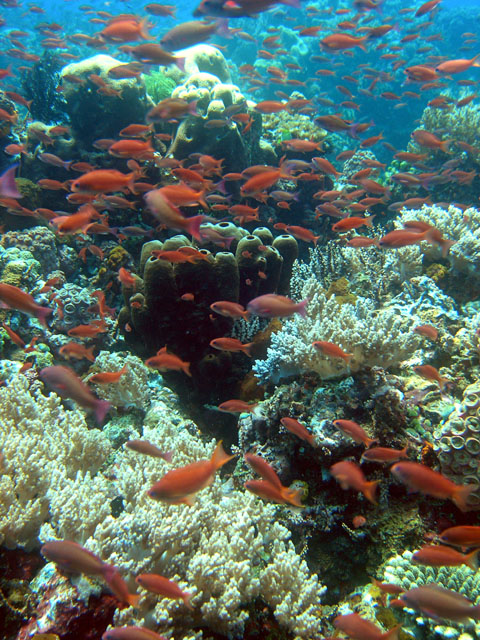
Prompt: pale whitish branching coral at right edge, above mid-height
<box><xmin>395</xmin><ymin>205</ymin><xmax>480</xmax><ymax>277</ymax></box>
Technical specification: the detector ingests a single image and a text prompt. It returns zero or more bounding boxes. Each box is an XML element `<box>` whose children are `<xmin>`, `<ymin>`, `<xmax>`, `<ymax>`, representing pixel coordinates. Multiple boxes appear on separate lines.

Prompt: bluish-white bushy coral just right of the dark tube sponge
<box><xmin>253</xmin><ymin>277</ymin><xmax>419</xmax><ymax>382</ymax></box>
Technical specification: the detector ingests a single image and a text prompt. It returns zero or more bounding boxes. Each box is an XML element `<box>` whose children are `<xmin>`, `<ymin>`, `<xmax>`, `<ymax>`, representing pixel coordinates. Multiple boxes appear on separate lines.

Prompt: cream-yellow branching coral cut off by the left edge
<box><xmin>0</xmin><ymin>375</ymin><xmax>110</xmax><ymax>549</ymax></box>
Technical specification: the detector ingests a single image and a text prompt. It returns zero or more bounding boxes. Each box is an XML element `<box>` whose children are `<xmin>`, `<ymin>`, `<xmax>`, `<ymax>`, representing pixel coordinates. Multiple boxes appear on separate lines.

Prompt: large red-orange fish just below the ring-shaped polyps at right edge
<box><xmin>390</xmin><ymin>462</ymin><xmax>479</xmax><ymax>511</ymax></box>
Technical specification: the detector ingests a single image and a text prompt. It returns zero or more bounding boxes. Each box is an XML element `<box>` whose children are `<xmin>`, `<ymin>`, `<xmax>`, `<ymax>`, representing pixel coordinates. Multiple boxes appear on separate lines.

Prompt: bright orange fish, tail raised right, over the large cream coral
<box><xmin>147</xmin><ymin>441</ymin><xmax>235</xmax><ymax>505</ymax></box>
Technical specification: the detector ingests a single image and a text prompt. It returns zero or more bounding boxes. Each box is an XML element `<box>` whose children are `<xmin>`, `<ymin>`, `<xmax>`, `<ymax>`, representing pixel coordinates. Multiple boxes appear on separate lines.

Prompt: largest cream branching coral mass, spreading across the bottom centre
<box><xmin>41</xmin><ymin>393</ymin><xmax>324</xmax><ymax>640</ymax></box>
